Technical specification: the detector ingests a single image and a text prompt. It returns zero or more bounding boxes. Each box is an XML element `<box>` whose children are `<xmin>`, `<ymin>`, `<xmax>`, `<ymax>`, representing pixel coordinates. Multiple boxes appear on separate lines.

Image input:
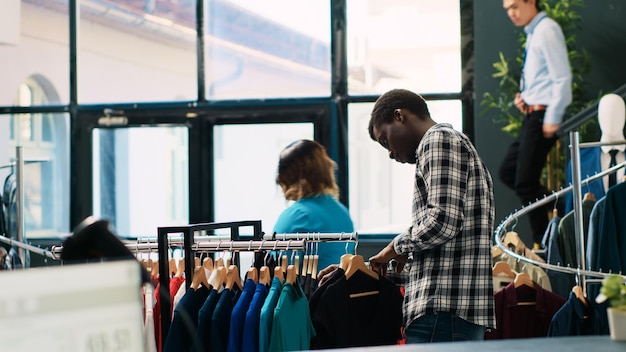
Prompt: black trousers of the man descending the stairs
<box><xmin>499</xmin><ymin>111</ymin><xmax>557</xmax><ymax>243</ymax></box>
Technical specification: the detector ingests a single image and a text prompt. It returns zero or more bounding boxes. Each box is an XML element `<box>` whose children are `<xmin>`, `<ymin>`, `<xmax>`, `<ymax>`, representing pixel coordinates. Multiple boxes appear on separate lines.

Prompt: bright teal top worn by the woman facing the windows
<box><xmin>273</xmin><ymin>194</ymin><xmax>355</xmax><ymax>270</ymax></box>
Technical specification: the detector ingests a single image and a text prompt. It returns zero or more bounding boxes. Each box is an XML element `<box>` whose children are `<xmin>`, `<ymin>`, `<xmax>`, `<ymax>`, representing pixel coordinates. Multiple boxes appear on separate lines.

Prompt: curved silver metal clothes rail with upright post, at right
<box><xmin>494</xmin><ymin>132</ymin><xmax>626</xmax><ymax>295</ymax></box>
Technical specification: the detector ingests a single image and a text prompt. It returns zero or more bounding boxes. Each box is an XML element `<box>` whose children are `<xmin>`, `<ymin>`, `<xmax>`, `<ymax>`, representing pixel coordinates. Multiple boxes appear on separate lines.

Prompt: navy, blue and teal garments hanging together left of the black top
<box><xmin>163</xmin><ymin>248</ymin><xmax>313</xmax><ymax>351</ymax></box>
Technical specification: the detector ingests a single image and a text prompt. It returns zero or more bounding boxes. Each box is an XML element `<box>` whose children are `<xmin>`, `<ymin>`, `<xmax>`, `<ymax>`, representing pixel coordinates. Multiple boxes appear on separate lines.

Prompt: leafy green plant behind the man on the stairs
<box><xmin>480</xmin><ymin>0</ymin><xmax>598</xmax><ymax>189</ymax></box>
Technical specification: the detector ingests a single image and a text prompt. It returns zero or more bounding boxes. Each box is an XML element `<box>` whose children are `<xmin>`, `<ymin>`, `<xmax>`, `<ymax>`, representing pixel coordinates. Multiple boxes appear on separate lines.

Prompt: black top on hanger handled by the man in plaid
<box><xmin>309</xmin><ymin>270</ymin><xmax>403</xmax><ymax>349</ymax></box>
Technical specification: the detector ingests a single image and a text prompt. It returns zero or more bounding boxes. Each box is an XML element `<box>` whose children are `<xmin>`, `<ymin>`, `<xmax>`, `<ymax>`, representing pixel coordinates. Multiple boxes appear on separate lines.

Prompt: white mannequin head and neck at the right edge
<box><xmin>598</xmin><ymin>93</ymin><xmax>626</xmax><ymax>190</ymax></box>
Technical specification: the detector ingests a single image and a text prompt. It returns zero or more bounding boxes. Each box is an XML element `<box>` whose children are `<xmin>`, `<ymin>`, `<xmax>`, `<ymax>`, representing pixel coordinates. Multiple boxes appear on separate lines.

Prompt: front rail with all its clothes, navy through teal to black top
<box><xmin>150</xmin><ymin>226</ymin><xmax>403</xmax><ymax>351</ymax></box>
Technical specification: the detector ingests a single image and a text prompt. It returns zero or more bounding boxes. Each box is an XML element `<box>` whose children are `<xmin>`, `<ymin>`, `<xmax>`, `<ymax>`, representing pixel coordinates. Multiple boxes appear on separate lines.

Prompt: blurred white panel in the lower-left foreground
<box><xmin>0</xmin><ymin>260</ymin><xmax>144</xmax><ymax>352</ymax></box>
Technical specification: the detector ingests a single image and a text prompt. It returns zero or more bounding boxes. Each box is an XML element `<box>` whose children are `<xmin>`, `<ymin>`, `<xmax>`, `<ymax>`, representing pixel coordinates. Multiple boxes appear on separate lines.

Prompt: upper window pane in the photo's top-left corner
<box><xmin>0</xmin><ymin>0</ymin><xmax>70</xmax><ymax>106</ymax></box>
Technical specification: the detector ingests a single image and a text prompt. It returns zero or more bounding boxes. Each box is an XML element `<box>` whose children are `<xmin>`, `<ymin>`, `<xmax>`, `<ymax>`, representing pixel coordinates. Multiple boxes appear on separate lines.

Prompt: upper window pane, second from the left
<box><xmin>78</xmin><ymin>0</ymin><xmax>197</xmax><ymax>103</ymax></box>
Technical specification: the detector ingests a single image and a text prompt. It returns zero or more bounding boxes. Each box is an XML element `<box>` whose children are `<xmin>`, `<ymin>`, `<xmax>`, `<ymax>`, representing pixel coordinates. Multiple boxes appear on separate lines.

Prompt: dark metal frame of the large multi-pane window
<box><xmin>0</xmin><ymin>0</ymin><xmax>474</xmax><ymax>241</ymax></box>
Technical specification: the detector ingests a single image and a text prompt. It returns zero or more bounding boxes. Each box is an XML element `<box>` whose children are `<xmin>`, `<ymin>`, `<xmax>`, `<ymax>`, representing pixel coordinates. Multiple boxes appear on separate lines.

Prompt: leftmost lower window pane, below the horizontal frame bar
<box><xmin>0</xmin><ymin>114</ymin><xmax>70</xmax><ymax>239</ymax></box>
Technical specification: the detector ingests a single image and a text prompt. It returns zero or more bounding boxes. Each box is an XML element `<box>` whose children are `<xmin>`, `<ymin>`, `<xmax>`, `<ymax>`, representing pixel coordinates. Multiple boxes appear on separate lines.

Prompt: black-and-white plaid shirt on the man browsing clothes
<box><xmin>394</xmin><ymin>124</ymin><xmax>495</xmax><ymax>328</ymax></box>
